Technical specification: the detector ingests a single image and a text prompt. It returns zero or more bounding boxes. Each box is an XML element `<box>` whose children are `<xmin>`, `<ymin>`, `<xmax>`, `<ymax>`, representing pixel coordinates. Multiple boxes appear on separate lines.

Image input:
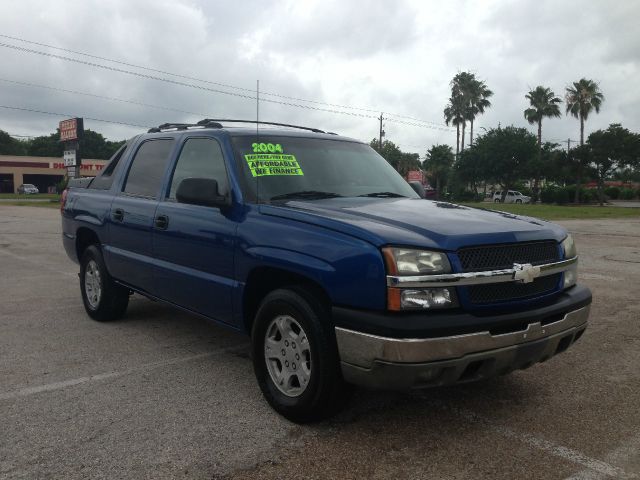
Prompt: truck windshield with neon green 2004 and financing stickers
<box><xmin>233</xmin><ymin>135</ymin><xmax>419</xmax><ymax>202</ymax></box>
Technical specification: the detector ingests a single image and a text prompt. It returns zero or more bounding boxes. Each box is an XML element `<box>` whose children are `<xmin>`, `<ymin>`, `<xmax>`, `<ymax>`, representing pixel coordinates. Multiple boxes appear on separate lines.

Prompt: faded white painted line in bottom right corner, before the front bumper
<box><xmin>430</xmin><ymin>403</ymin><xmax>640</xmax><ymax>480</ymax></box>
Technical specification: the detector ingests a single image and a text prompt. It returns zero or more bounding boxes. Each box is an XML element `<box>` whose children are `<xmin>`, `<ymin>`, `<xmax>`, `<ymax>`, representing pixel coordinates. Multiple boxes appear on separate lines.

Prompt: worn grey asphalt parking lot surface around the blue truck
<box><xmin>0</xmin><ymin>205</ymin><xmax>640</xmax><ymax>479</ymax></box>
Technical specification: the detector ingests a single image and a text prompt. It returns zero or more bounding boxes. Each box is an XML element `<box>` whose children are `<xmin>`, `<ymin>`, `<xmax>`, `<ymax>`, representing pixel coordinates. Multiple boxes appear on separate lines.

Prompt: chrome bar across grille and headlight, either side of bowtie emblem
<box><xmin>387</xmin><ymin>257</ymin><xmax>578</xmax><ymax>288</ymax></box>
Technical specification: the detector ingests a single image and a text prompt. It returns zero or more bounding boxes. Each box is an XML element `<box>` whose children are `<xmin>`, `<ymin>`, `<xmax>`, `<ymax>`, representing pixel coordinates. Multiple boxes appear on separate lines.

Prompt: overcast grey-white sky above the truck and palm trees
<box><xmin>0</xmin><ymin>0</ymin><xmax>640</xmax><ymax>156</ymax></box>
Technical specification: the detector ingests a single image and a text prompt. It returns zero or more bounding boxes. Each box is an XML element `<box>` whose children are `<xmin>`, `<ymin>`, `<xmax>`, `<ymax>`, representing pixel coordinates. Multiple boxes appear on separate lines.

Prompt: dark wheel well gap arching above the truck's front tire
<box><xmin>242</xmin><ymin>267</ymin><xmax>331</xmax><ymax>333</ymax></box>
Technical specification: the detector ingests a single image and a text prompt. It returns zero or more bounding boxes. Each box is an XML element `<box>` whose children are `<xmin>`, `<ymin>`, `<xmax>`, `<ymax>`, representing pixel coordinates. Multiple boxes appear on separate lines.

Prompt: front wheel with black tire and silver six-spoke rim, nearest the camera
<box><xmin>251</xmin><ymin>287</ymin><xmax>351</xmax><ymax>423</ymax></box>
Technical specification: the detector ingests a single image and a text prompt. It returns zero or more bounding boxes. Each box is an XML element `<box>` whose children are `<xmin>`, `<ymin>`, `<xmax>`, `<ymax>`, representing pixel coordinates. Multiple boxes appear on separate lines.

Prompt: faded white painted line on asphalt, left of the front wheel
<box><xmin>0</xmin><ymin>344</ymin><xmax>245</xmax><ymax>400</ymax></box>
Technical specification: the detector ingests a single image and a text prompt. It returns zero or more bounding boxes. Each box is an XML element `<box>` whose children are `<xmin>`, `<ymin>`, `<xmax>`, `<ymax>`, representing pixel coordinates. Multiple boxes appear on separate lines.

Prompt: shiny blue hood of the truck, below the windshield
<box><xmin>260</xmin><ymin>197</ymin><xmax>567</xmax><ymax>250</ymax></box>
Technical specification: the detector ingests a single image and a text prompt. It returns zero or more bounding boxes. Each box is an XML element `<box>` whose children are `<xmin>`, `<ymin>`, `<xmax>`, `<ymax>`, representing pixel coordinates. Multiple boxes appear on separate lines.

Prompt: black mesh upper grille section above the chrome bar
<box><xmin>457</xmin><ymin>240</ymin><xmax>560</xmax><ymax>272</ymax></box>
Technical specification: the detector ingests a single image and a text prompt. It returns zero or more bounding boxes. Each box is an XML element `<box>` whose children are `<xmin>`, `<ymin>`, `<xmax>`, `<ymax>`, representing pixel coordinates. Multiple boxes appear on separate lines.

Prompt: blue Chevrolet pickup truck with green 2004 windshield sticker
<box><xmin>61</xmin><ymin>120</ymin><xmax>591</xmax><ymax>422</ymax></box>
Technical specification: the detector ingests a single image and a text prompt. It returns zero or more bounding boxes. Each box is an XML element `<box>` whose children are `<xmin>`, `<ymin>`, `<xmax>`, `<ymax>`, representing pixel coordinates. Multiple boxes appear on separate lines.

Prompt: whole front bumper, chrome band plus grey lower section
<box><xmin>335</xmin><ymin>299</ymin><xmax>590</xmax><ymax>390</ymax></box>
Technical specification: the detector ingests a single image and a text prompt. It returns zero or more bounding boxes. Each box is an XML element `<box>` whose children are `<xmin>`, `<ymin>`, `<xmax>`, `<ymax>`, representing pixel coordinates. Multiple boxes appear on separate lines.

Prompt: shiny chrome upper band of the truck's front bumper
<box><xmin>335</xmin><ymin>305</ymin><xmax>591</xmax><ymax>369</ymax></box>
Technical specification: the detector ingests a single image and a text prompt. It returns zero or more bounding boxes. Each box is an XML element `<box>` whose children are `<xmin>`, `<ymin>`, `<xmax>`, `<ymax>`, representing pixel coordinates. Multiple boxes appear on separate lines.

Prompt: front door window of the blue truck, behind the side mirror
<box><xmin>169</xmin><ymin>138</ymin><xmax>229</xmax><ymax>199</ymax></box>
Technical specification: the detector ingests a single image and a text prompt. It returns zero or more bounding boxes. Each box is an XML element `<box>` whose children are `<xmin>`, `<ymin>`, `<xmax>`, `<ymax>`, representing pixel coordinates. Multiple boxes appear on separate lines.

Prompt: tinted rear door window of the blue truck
<box><xmin>124</xmin><ymin>139</ymin><xmax>173</xmax><ymax>198</ymax></box>
